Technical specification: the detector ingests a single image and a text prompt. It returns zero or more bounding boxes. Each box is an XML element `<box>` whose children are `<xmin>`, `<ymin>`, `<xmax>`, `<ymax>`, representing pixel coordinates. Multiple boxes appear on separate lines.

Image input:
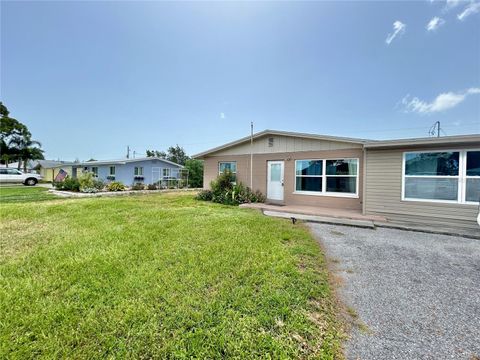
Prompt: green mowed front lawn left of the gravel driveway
<box><xmin>0</xmin><ymin>194</ymin><xmax>342</xmax><ymax>359</ymax></box>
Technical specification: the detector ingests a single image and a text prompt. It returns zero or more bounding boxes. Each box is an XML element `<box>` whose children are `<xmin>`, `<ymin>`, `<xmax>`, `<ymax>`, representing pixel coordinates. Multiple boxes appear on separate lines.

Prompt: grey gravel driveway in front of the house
<box><xmin>309</xmin><ymin>224</ymin><xmax>480</xmax><ymax>359</ymax></box>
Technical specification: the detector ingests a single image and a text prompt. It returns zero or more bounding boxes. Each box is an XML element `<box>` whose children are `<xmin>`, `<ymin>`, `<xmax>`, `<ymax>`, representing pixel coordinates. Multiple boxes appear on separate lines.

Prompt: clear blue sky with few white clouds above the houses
<box><xmin>0</xmin><ymin>0</ymin><xmax>480</xmax><ymax>160</ymax></box>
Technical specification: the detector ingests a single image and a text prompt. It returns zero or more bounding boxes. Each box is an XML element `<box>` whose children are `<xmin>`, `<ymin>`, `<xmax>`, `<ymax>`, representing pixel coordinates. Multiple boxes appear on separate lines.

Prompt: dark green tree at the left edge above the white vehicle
<box><xmin>0</xmin><ymin>102</ymin><xmax>43</xmax><ymax>170</ymax></box>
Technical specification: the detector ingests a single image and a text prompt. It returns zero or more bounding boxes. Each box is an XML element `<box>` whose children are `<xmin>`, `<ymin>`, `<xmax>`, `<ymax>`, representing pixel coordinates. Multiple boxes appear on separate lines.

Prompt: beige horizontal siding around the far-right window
<box><xmin>365</xmin><ymin>146</ymin><xmax>478</xmax><ymax>229</ymax></box>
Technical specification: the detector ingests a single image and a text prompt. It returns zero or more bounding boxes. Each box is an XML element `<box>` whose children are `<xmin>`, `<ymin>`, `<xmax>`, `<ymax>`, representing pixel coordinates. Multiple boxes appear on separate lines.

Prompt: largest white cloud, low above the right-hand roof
<box><xmin>402</xmin><ymin>88</ymin><xmax>480</xmax><ymax>114</ymax></box>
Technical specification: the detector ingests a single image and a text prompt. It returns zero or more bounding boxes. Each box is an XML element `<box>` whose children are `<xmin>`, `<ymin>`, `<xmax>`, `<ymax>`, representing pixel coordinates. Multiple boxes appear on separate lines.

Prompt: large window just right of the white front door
<box><xmin>295</xmin><ymin>159</ymin><xmax>358</xmax><ymax>196</ymax></box>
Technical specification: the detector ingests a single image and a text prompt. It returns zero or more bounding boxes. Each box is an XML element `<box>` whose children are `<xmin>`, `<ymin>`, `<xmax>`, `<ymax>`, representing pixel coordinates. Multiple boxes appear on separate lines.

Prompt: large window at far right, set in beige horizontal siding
<box><xmin>402</xmin><ymin>151</ymin><xmax>480</xmax><ymax>203</ymax></box>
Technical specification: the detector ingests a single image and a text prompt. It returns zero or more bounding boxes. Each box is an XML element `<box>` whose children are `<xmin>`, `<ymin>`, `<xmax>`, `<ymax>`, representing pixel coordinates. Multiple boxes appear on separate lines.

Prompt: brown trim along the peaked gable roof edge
<box><xmin>192</xmin><ymin>129</ymin><xmax>372</xmax><ymax>159</ymax></box>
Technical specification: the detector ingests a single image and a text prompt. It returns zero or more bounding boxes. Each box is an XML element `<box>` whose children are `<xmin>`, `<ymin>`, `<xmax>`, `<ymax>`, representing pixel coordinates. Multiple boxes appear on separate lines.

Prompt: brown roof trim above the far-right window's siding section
<box><xmin>364</xmin><ymin>134</ymin><xmax>480</xmax><ymax>149</ymax></box>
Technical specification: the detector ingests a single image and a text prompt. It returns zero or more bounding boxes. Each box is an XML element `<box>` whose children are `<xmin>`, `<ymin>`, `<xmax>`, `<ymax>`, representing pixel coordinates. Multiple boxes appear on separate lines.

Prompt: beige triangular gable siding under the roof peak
<box><xmin>206</xmin><ymin>135</ymin><xmax>362</xmax><ymax>156</ymax></box>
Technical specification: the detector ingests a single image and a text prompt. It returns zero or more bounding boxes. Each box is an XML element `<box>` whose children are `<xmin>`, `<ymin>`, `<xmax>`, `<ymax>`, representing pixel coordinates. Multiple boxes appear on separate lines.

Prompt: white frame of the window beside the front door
<box><xmin>293</xmin><ymin>158</ymin><xmax>360</xmax><ymax>199</ymax></box>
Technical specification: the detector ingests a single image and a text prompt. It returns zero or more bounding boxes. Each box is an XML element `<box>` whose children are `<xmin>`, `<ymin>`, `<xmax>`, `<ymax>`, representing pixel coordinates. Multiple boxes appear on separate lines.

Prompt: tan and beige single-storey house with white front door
<box><xmin>194</xmin><ymin>130</ymin><xmax>480</xmax><ymax>229</ymax></box>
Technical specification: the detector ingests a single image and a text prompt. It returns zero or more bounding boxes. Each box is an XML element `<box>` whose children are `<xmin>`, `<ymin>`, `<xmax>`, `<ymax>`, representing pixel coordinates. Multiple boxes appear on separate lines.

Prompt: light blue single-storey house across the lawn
<box><xmin>72</xmin><ymin>157</ymin><xmax>186</xmax><ymax>186</ymax></box>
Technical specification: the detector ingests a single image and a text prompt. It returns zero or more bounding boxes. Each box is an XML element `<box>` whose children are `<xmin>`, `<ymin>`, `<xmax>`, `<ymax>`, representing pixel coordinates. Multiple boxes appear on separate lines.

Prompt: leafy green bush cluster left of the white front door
<box><xmin>197</xmin><ymin>170</ymin><xmax>265</xmax><ymax>205</ymax></box>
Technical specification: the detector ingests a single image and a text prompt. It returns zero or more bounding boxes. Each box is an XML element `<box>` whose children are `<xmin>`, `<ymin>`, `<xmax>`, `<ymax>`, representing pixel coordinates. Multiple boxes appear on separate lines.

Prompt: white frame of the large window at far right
<box><xmin>401</xmin><ymin>149</ymin><xmax>480</xmax><ymax>205</ymax></box>
